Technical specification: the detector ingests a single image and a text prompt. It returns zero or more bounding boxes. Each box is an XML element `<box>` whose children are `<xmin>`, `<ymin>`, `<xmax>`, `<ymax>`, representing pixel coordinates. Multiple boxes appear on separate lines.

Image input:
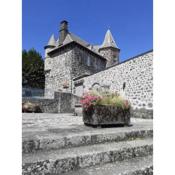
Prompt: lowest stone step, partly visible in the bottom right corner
<box><xmin>63</xmin><ymin>155</ymin><xmax>153</xmax><ymax>175</ymax></box>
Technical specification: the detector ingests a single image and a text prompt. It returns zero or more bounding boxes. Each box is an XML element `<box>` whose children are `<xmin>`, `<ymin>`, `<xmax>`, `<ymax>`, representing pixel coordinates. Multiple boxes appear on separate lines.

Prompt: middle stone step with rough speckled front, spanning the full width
<box><xmin>23</xmin><ymin>139</ymin><xmax>153</xmax><ymax>175</ymax></box>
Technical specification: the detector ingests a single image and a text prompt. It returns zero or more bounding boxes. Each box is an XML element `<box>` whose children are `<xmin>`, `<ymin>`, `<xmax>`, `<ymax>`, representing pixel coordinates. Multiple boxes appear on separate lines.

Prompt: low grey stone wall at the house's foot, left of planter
<box><xmin>22</xmin><ymin>92</ymin><xmax>80</xmax><ymax>113</ymax></box>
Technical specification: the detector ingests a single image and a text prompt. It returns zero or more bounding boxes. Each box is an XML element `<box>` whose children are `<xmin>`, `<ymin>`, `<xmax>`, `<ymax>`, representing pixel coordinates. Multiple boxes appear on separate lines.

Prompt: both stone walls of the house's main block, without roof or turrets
<box><xmin>45</xmin><ymin>43</ymin><xmax>106</xmax><ymax>98</ymax></box>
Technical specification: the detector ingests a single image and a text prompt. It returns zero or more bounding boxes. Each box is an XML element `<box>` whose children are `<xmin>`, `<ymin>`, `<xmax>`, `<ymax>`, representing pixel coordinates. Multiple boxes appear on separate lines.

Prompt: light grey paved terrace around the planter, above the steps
<box><xmin>22</xmin><ymin>113</ymin><xmax>152</xmax><ymax>141</ymax></box>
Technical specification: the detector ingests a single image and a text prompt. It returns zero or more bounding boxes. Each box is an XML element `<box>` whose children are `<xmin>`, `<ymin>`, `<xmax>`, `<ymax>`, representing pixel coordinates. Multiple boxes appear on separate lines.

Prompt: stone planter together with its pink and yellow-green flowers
<box><xmin>81</xmin><ymin>91</ymin><xmax>130</xmax><ymax>126</ymax></box>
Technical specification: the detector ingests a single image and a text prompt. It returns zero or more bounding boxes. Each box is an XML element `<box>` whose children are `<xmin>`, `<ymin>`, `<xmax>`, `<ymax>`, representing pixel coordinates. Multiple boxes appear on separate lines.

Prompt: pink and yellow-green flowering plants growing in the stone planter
<box><xmin>80</xmin><ymin>91</ymin><xmax>130</xmax><ymax>110</ymax></box>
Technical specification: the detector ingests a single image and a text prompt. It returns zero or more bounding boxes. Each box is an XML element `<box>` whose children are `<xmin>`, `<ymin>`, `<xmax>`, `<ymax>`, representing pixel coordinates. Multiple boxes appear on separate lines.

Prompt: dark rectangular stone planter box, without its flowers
<box><xmin>83</xmin><ymin>105</ymin><xmax>130</xmax><ymax>126</ymax></box>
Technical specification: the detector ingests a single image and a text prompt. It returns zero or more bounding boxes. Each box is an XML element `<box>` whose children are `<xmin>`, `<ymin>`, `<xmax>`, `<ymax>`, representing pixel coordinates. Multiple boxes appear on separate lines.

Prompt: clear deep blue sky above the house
<box><xmin>22</xmin><ymin>0</ymin><xmax>153</xmax><ymax>61</ymax></box>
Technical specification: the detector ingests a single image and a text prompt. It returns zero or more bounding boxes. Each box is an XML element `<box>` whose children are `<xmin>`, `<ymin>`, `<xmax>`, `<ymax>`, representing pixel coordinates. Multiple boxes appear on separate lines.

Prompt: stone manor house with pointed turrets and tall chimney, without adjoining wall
<box><xmin>45</xmin><ymin>21</ymin><xmax>120</xmax><ymax>96</ymax></box>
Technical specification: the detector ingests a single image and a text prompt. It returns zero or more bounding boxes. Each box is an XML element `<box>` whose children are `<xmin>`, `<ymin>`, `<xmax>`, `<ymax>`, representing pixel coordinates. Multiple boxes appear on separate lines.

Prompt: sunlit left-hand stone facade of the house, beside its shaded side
<box><xmin>45</xmin><ymin>47</ymin><xmax>73</xmax><ymax>98</ymax></box>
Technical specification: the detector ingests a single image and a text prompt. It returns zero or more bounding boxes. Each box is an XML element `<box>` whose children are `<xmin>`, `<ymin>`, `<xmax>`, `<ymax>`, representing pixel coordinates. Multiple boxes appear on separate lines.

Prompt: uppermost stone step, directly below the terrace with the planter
<box><xmin>22</xmin><ymin>127</ymin><xmax>153</xmax><ymax>153</ymax></box>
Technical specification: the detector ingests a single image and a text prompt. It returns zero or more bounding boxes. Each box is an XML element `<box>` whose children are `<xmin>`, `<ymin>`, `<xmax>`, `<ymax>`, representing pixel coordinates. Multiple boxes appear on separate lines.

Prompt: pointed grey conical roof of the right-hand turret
<box><xmin>101</xmin><ymin>29</ymin><xmax>119</xmax><ymax>49</ymax></box>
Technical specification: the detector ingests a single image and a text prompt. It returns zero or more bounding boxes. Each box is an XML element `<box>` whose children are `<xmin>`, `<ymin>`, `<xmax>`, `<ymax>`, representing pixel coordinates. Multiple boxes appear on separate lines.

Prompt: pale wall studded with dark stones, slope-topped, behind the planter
<box><xmin>75</xmin><ymin>51</ymin><xmax>153</xmax><ymax>110</ymax></box>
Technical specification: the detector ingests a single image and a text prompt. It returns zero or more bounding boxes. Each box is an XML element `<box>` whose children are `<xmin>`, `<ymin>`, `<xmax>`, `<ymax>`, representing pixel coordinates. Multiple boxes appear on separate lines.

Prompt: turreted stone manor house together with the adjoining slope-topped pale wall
<box><xmin>44</xmin><ymin>20</ymin><xmax>153</xmax><ymax>114</ymax></box>
